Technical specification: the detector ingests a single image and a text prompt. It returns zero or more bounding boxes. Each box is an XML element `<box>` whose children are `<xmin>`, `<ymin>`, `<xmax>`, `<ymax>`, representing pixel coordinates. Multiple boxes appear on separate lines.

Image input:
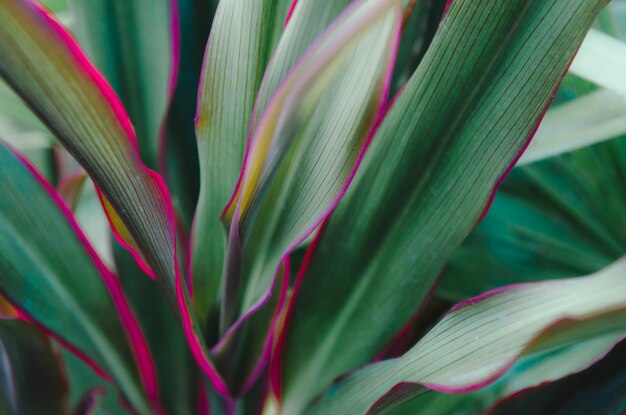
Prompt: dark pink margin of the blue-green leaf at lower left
<box><xmin>14</xmin><ymin>148</ymin><xmax>163</xmax><ymax>414</ymax></box>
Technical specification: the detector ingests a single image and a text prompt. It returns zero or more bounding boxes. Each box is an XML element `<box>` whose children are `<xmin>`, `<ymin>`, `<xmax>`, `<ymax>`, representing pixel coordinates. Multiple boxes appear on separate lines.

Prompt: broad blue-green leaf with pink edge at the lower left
<box><xmin>0</xmin><ymin>145</ymin><xmax>159</xmax><ymax>413</ymax></box>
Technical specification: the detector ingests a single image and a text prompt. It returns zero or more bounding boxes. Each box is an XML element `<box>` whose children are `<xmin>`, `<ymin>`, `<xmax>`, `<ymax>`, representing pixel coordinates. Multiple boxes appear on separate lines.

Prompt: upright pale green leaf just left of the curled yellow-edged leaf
<box><xmin>192</xmin><ymin>0</ymin><xmax>285</xmax><ymax>330</ymax></box>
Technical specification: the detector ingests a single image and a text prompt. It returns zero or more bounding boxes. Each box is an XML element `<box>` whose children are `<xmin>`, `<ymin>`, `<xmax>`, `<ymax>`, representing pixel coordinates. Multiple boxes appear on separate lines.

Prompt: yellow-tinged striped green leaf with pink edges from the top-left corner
<box><xmin>0</xmin><ymin>0</ymin><xmax>228</xmax><ymax>394</ymax></box>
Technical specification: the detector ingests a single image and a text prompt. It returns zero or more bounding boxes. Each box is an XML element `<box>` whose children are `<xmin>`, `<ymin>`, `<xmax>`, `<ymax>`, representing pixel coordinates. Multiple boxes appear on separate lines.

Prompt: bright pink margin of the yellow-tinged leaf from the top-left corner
<box><xmin>21</xmin><ymin>0</ymin><xmax>229</xmax><ymax>395</ymax></box>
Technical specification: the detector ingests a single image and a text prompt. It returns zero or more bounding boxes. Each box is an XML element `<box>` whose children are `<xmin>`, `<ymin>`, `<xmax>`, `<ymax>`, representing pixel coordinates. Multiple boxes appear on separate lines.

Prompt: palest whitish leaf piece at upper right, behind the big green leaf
<box><xmin>570</xmin><ymin>29</ymin><xmax>626</xmax><ymax>95</ymax></box>
